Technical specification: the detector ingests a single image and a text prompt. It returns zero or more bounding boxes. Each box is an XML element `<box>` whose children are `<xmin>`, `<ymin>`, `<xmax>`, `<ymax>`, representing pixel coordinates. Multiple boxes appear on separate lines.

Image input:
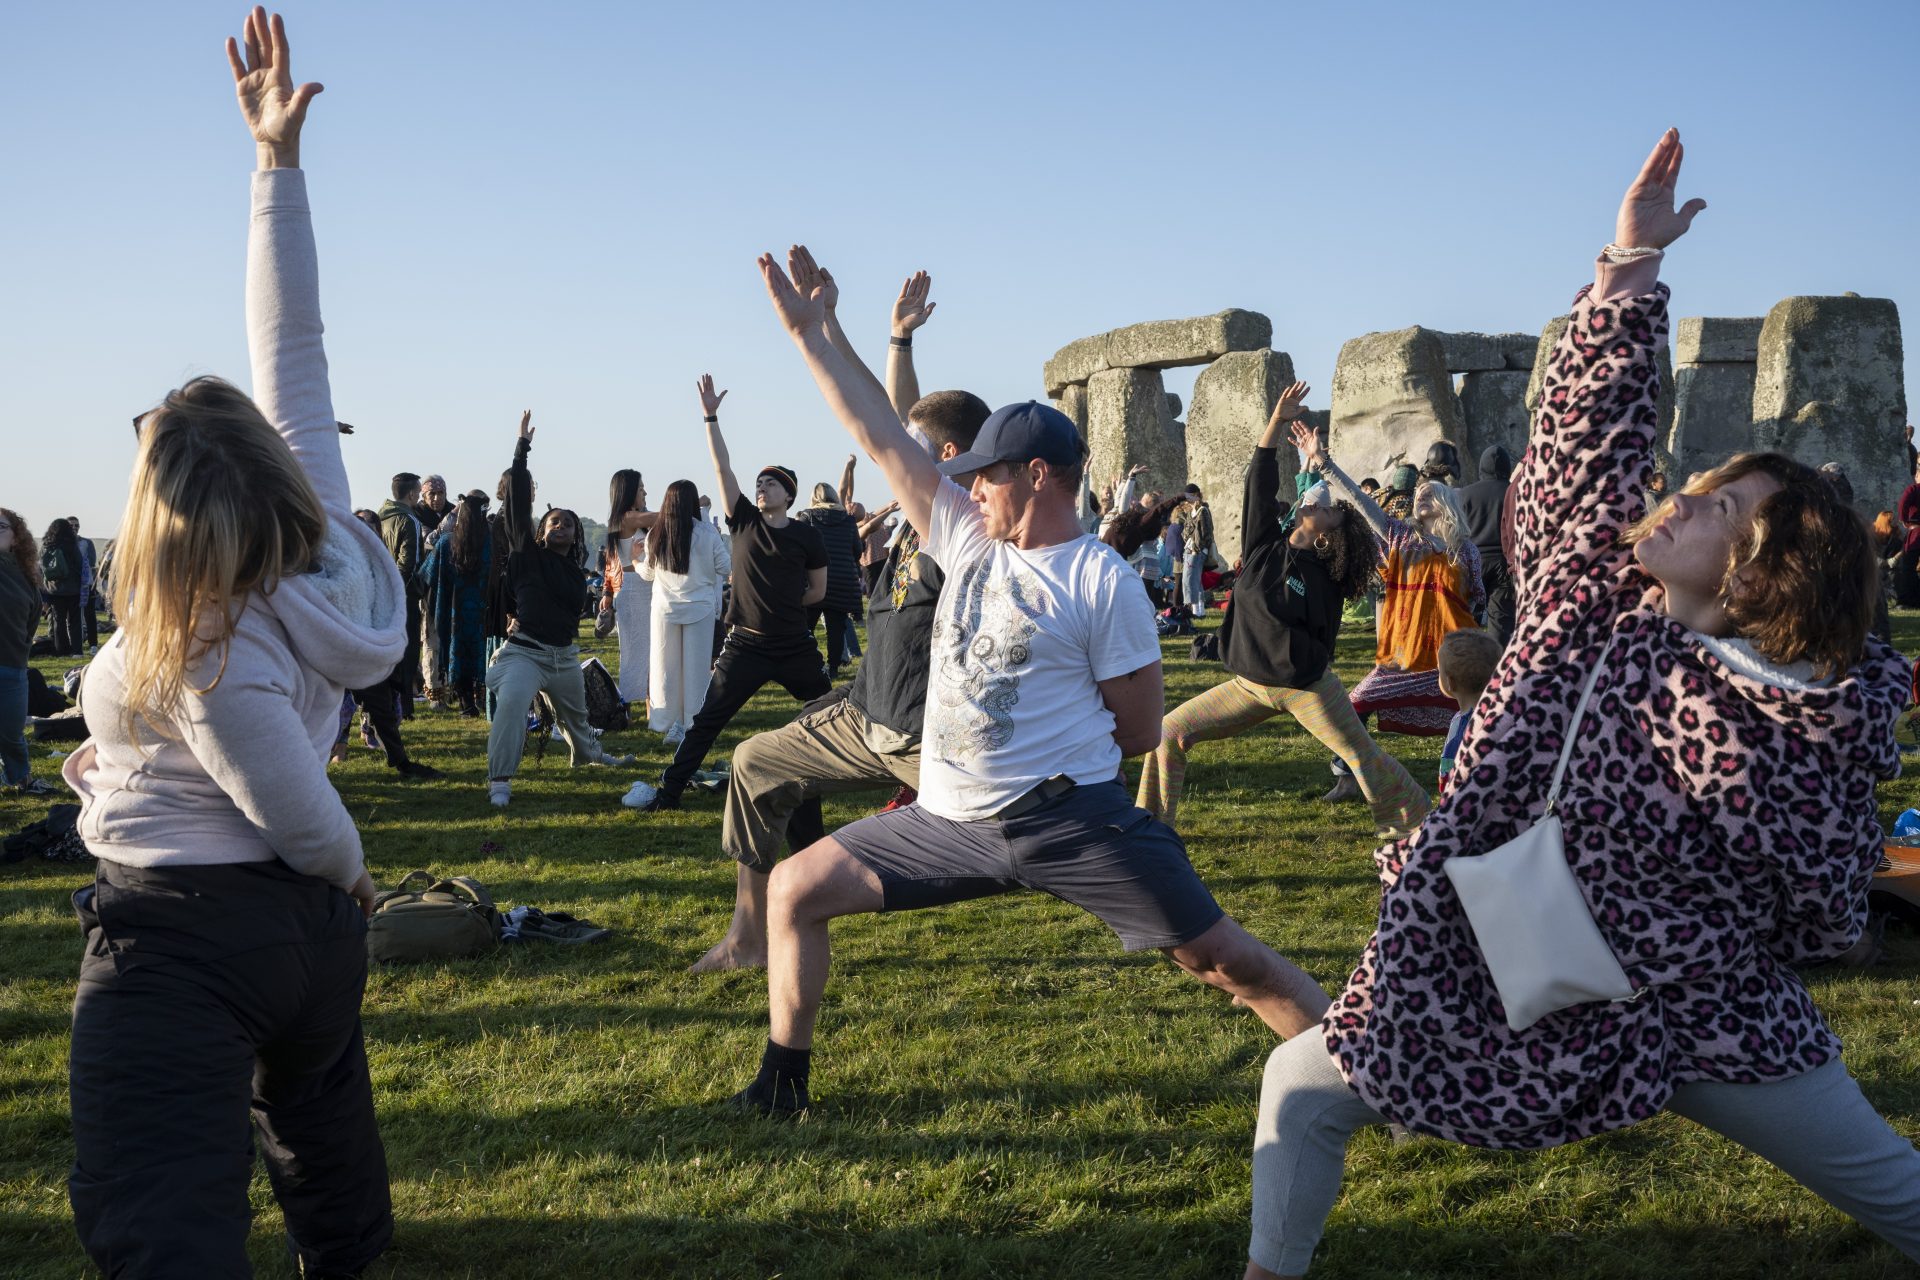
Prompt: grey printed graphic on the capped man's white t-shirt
<box><xmin>925</xmin><ymin>560</ymin><xmax>1050</xmax><ymax>762</ymax></box>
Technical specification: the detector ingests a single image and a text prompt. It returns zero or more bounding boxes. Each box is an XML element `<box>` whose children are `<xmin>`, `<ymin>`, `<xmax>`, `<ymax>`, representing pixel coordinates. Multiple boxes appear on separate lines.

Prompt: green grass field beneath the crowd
<box><xmin>0</xmin><ymin>616</ymin><xmax>1920</xmax><ymax>1280</ymax></box>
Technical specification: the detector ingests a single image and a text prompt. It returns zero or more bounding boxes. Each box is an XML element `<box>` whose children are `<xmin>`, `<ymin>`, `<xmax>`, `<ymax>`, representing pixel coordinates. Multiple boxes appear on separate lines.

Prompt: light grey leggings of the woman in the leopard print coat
<box><xmin>1246</xmin><ymin>1031</ymin><xmax>1920</xmax><ymax>1276</ymax></box>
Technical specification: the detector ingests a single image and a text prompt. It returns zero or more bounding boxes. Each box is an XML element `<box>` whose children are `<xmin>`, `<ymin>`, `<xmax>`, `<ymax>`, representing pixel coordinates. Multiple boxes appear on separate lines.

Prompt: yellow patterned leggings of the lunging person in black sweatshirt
<box><xmin>1135</xmin><ymin>672</ymin><xmax>1430</xmax><ymax>837</ymax></box>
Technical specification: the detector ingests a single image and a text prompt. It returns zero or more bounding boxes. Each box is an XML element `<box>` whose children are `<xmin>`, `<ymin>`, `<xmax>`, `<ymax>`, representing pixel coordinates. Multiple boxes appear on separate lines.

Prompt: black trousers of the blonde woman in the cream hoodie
<box><xmin>67</xmin><ymin>862</ymin><xmax>394</xmax><ymax>1280</ymax></box>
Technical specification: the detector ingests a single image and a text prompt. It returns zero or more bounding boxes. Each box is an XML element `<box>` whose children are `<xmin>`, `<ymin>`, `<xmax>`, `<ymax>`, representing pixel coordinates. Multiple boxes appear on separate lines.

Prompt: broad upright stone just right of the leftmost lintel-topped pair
<box><xmin>1327</xmin><ymin>324</ymin><xmax>1463</xmax><ymax>480</ymax></box>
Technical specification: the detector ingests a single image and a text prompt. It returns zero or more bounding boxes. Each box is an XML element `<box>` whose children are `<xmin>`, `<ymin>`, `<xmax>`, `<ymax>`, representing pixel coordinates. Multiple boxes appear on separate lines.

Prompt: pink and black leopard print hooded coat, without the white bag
<box><xmin>1323</xmin><ymin>260</ymin><xmax>1907</xmax><ymax>1148</ymax></box>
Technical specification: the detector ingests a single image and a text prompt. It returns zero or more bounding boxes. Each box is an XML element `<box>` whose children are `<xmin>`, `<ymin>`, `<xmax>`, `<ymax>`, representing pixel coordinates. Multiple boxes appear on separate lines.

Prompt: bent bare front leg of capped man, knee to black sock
<box><xmin>766</xmin><ymin>837</ymin><xmax>883</xmax><ymax>1050</ymax></box>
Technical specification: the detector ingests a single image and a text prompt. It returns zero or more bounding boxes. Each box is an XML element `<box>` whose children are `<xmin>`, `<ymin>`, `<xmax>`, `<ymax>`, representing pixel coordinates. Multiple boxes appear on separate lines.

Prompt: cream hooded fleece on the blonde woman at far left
<box><xmin>63</xmin><ymin>169</ymin><xmax>407</xmax><ymax>889</ymax></box>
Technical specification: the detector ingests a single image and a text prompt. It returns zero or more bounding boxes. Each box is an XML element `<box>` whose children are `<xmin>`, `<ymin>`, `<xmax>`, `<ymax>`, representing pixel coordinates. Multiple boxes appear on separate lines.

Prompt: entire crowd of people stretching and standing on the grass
<box><xmin>0</xmin><ymin>10</ymin><xmax>1920</xmax><ymax>1278</ymax></box>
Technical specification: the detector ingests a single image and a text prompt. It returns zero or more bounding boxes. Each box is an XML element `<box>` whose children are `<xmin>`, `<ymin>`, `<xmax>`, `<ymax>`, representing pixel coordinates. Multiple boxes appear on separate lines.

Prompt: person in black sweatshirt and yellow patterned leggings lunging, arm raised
<box><xmin>1137</xmin><ymin>382</ymin><xmax>1427</xmax><ymax>835</ymax></box>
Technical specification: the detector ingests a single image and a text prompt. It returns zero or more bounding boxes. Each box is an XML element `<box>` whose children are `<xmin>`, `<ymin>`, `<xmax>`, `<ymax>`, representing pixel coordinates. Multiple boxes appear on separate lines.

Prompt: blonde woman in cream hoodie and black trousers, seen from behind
<box><xmin>65</xmin><ymin>10</ymin><xmax>407</xmax><ymax>1276</ymax></box>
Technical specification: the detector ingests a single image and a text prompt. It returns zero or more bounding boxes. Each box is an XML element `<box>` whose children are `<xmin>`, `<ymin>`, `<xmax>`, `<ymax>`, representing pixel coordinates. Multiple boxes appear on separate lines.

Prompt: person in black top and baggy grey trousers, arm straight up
<box><xmin>486</xmin><ymin>409</ymin><xmax>634</xmax><ymax>808</ymax></box>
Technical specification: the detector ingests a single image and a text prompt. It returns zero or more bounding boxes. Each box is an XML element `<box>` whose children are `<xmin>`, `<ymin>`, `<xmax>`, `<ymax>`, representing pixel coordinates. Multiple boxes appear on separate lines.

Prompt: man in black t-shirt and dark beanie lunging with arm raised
<box><xmin>626</xmin><ymin>376</ymin><xmax>828</xmax><ymax>812</ymax></box>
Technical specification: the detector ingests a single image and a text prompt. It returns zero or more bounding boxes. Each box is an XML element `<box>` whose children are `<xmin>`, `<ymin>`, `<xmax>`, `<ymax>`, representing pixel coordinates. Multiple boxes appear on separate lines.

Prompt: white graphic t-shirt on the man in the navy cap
<box><xmin>920</xmin><ymin>480</ymin><xmax>1160</xmax><ymax>821</ymax></box>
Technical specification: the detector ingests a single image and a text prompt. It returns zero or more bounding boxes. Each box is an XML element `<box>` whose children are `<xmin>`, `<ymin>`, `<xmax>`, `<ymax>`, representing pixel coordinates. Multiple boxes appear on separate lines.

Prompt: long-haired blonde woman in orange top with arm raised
<box><xmin>1292</xmin><ymin>422</ymin><xmax>1486</xmax><ymax>800</ymax></box>
